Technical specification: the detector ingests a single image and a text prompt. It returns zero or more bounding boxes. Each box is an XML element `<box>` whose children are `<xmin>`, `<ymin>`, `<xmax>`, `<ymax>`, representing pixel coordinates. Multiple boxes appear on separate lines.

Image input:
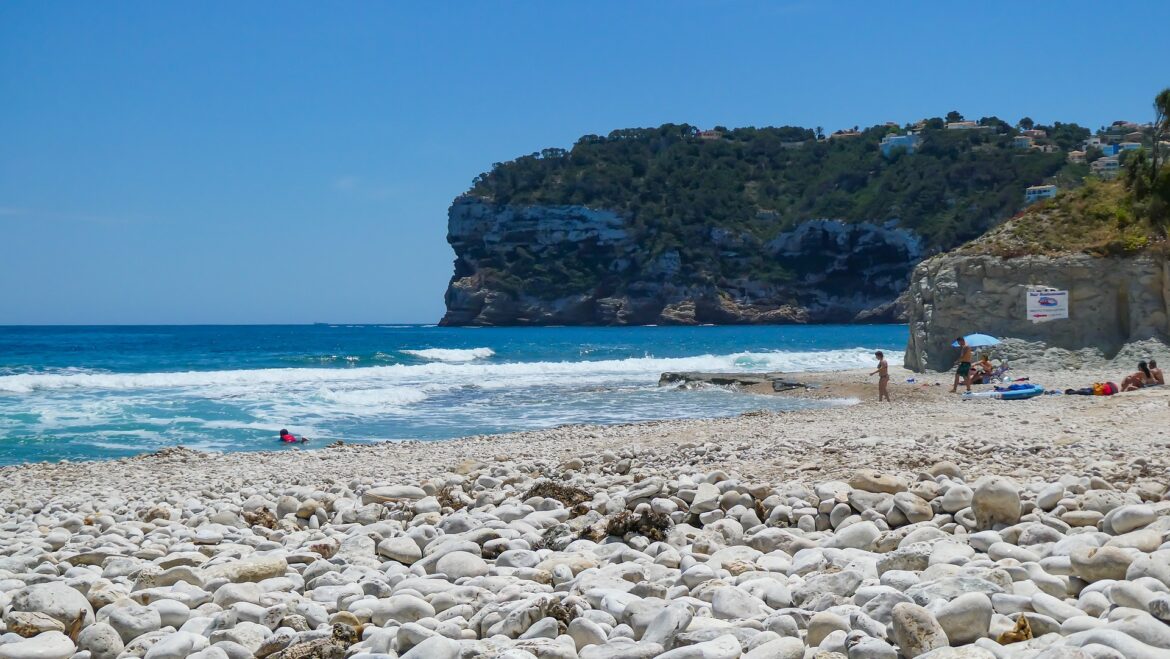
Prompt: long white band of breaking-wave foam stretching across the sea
<box><xmin>0</xmin><ymin>348</ymin><xmax>901</xmax><ymax>398</ymax></box>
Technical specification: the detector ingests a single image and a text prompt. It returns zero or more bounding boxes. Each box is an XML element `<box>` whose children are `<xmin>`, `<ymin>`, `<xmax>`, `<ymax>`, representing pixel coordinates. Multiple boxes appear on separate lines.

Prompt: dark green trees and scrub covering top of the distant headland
<box><xmin>470</xmin><ymin>117</ymin><xmax>1089</xmax><ymax>252</ymax></box>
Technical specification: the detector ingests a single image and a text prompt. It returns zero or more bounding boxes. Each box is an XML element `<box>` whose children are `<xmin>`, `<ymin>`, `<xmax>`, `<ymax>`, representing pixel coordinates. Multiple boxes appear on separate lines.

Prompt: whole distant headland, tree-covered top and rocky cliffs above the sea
<box><xmin>441</xmin><ymin>117</ymin><xmax>1089</xmax><ymax>325</ymax></box>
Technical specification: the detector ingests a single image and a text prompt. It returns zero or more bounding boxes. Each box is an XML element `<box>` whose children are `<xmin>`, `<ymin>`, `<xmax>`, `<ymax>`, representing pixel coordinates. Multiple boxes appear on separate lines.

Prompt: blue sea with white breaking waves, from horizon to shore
<box><xmin>0</xmin><ymin>324</ymin><xmax>907</xmax><ymax>465</ymax></box>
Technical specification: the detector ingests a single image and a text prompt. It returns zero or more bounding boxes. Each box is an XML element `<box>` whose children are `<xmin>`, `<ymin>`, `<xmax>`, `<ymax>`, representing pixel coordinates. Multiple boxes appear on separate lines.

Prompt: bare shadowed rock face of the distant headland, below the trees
<box><xmin>441</xmin><ymin>195</ymin><xmax>923</xmax><ymax>325</ymax></box>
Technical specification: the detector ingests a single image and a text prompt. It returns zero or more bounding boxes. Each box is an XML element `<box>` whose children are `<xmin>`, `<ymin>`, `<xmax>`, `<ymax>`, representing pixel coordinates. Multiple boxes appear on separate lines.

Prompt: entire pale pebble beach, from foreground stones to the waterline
<box><xmin>0</xmin><ymin>369</ymin><xmax>1170</xmax><ymax>659</ymax></box>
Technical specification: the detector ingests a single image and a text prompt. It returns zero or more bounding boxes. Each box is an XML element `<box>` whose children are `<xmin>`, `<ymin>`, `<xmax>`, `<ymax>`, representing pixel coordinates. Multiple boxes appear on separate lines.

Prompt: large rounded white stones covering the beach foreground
<box><xmin>0</xmin><ymin>444</ymin><xmax>1170</xmax><ymax>659</ymax></box>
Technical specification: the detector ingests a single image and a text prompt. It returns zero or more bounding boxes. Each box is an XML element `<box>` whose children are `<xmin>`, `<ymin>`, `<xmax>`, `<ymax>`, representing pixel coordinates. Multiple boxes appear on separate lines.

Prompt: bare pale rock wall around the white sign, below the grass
<box><xmin>906</xmin><ymin>250</ymin><xmax>1170</xmax><ymax>371</ymax></box>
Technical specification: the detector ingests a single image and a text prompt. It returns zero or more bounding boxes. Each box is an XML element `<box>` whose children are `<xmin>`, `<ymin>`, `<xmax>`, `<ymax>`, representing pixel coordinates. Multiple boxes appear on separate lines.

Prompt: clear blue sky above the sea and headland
<box><xmin>0</xmin><ymin>0</ymin><xmax>1170</xmax><ymax>324</ymax></box>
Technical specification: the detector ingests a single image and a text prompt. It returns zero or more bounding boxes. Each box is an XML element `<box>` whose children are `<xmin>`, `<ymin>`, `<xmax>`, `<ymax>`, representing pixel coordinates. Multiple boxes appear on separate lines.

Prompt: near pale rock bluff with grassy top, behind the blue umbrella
<box><xmin>906</xmin><ymin>184</ymin><xmax>1170</xmax><ymax>371</ymax></box>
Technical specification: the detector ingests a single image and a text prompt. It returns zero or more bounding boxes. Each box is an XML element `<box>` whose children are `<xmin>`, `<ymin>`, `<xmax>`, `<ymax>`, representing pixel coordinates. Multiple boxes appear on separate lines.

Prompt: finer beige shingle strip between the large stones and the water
<box><xmin>0</xmin><ymin>368</ymin><xmax>1170</xmax><ymax>501</ymax></box>
